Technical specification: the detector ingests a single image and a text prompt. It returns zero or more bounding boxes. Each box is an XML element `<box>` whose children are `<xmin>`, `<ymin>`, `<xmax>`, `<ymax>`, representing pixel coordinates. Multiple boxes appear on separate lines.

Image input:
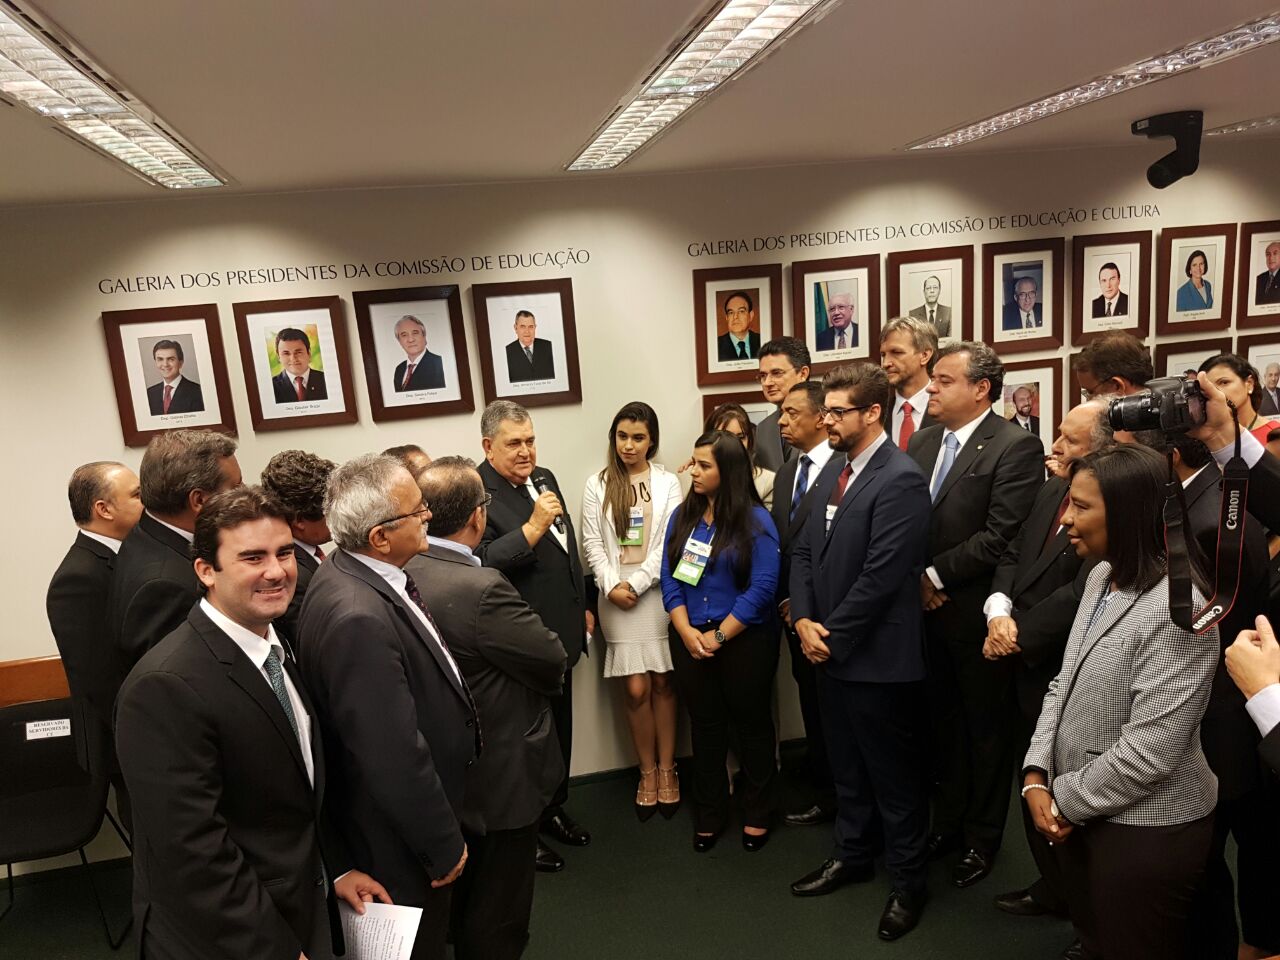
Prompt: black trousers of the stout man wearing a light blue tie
<box><xmin>925</xmin><ymin>603</ymin><xmax>1012</xmax><ymax>854</ymax></box>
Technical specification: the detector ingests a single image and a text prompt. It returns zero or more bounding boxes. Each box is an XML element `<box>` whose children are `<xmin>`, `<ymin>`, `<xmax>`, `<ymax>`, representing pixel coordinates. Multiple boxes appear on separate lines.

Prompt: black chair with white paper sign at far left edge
<box><xmin>0</xmin><ymin>698</ymin><xmax>133</xmax><ymax>950</ymax></box>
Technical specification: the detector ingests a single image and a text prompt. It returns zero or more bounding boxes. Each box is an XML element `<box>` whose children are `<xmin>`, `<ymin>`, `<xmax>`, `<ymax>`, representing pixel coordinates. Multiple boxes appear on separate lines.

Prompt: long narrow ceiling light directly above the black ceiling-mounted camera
<box><xmin>908</xmin><ymin>14</ymin><xmax>1280</xmax><ymax>150</ymax></box>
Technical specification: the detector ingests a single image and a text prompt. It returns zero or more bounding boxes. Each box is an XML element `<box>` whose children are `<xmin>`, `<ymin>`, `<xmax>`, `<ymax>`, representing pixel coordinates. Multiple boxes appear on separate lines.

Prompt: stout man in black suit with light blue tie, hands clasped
<box><xmin>906</xmin><ymin>342</ymin><xmax>1044</xmax><ymax>887</ymax></box>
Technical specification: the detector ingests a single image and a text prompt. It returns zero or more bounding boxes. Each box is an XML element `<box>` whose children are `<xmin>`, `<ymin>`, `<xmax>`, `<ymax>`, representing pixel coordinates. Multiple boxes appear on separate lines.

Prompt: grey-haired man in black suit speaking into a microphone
<box><xmin>475</xmin><ymin>401</ymin><xmax>595</xmax><ymax>872</ymax></box>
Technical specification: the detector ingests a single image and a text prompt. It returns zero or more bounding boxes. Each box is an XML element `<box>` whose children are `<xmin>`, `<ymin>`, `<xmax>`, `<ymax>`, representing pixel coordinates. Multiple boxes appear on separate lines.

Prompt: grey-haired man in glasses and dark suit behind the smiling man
<box><xmin>298</xmin><ymin>454</ymin><xmax>480</xmax><ymax>960</ymax></box>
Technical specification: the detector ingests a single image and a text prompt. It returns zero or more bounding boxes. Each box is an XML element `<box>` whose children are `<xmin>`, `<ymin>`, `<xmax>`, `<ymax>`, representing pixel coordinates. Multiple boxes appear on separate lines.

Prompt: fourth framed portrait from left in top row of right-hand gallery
<box><xmin>982</xmin><ymin>237</ymin><xmax>1066</xmax><ymax>355</ymax></box>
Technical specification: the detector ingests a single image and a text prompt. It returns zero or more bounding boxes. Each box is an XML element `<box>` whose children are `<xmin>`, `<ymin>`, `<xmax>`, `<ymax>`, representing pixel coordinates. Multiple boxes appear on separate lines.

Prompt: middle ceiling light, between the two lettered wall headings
<box><xmin>566</xmin><ymin>0</ymin><xmax>840</xmax><ymax>170</ymax></box>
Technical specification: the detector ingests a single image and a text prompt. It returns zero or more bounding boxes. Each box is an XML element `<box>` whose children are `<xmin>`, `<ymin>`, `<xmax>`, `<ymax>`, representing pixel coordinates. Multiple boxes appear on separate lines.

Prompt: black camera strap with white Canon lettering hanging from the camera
<box><xmin>1165</xmin><ymin>401</ymin><xmax>1249</xmax><ymax>635</ymax></box>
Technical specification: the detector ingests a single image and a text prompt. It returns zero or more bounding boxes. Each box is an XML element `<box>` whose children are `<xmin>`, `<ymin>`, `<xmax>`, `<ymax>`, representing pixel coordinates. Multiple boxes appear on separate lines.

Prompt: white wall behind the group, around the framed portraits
<box><xmin>0</xmin><ymin>141</ymin><xmax>1280</xmax><ymax>819</ymax></box>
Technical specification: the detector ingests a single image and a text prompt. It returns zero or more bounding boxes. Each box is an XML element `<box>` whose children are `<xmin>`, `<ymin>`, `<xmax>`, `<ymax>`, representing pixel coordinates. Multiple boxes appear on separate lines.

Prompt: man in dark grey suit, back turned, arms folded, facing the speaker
<box><xmin>404</xmin><ymin>457</ymin><xmax>566</xmax><ymax>960</ymax></box>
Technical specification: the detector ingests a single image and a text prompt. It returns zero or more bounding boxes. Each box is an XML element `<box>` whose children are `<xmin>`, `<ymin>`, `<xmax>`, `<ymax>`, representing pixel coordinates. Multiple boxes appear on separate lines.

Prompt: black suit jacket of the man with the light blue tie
<box><xmin>906</xmin><ymin>411</ymin><xmax>1044</xmax><ymax>624</ymax></box>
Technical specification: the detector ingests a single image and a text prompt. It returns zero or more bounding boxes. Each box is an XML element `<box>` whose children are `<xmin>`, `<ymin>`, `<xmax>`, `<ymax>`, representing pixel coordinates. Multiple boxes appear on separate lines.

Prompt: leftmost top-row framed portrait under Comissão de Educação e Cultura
<box><xmin>694</xmin><ymin>264</ymin><xmax>782</xmax><ymax>387</ymax></box>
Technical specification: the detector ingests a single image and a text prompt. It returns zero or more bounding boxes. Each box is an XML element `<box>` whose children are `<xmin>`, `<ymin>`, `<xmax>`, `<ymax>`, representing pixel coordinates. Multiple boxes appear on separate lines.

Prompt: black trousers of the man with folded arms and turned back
<box><xmin>452</xmin><ymin>823</ymin><xmax>538</xmax><ymax>960</ymax></box>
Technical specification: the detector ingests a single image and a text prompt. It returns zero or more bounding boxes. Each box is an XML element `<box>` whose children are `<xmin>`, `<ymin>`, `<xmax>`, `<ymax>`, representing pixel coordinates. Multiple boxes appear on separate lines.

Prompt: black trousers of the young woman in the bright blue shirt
<box><xmin>667</xmin><ymin>625</ymin><xmax>780</xmax><ymax>833</ymax></box>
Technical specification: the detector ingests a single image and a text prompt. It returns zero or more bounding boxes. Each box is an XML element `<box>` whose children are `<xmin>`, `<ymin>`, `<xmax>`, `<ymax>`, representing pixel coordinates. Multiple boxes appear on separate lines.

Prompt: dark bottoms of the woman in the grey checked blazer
<box><xmin>1053</xmin><ymin>814</ymin><xmax>1213</xmax><ymax>960</ymax></box>
